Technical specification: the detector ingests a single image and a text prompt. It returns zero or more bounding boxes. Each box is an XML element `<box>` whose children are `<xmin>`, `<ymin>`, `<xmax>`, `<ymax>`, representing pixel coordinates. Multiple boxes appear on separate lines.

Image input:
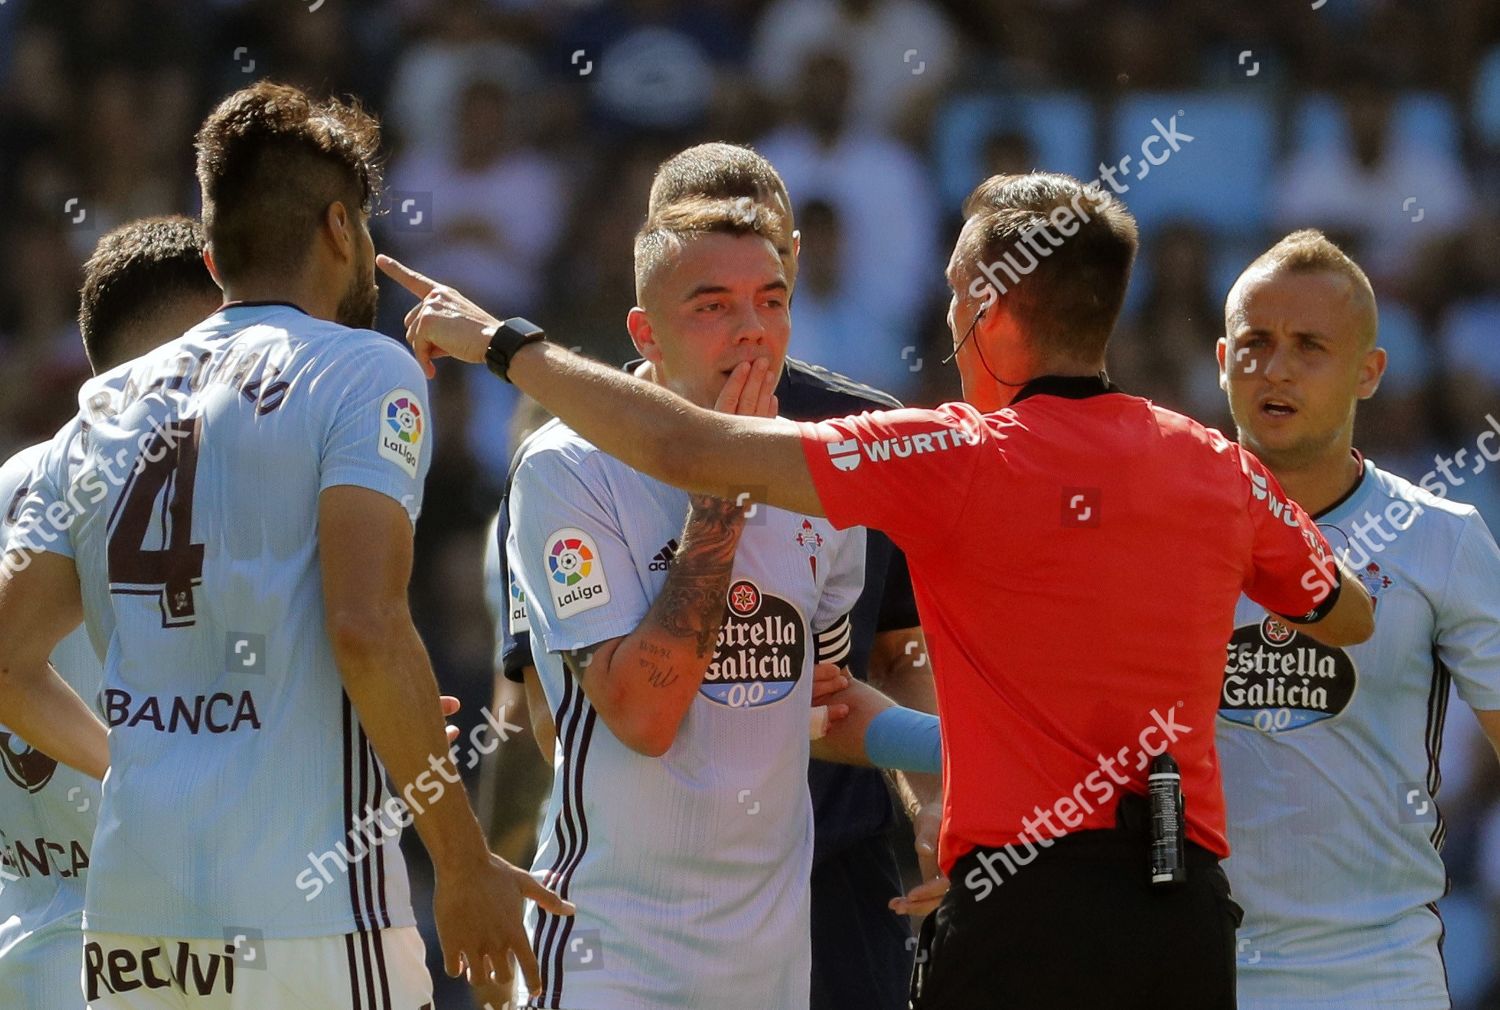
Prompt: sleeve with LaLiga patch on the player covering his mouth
<box><xmin>510</xmin><ymin>444</ymin><xmax>651</xmax><ymax>653</ymax></box>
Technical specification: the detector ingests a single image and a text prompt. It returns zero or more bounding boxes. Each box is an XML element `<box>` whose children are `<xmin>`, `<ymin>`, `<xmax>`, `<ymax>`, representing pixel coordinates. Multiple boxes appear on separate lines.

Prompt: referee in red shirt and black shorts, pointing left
<box><xmin>383</xmin><ymin>174</ymin><xmax>1374</xmax><ymax>1010</ymax></box>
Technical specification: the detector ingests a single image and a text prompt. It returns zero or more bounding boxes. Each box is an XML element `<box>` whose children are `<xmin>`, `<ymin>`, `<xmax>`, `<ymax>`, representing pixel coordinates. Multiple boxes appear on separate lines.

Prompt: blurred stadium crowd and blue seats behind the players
<box><xmin>0</xmin><ymin>0</ymin><xmax>1500</xmax><ymax>1010</ymax></box>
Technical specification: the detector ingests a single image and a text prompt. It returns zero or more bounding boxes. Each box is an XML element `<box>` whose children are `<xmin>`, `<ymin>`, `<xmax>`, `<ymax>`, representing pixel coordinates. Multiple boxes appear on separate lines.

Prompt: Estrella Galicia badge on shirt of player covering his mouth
<box><xmin>699</xmin><ymin>579</ymin><xmax>807</xmax><ymax>708</ymax></box>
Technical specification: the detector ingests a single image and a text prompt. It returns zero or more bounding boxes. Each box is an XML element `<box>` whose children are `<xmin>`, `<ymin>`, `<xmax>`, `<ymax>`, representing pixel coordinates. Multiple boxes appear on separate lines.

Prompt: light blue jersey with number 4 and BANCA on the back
<box><xmin>12</xmin><ymin>303</ymin><xmax>432</xmax><ymax>939</ymax></box>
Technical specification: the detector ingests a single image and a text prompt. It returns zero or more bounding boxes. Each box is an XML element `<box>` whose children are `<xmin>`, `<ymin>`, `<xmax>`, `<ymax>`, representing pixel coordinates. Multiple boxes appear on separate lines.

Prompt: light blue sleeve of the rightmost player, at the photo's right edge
<box><xmin>1436</xmin><ymin>512</ymin><xmax>1500</xmax><ymax>711</ymax></box>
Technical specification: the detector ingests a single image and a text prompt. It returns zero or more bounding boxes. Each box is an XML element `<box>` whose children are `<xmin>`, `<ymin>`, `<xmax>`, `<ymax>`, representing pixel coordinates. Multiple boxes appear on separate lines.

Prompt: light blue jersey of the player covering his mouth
<box><xmin>507</xmin><ymin>422</ymin><xmax>864</xmax><ymax>1010</ymax></box>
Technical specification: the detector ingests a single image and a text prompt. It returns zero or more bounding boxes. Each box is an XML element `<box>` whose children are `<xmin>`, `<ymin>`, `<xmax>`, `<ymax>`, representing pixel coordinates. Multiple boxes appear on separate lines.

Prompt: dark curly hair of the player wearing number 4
<box><xmin>197</xmin><ymin>81</ymin><xmax>381</xmax><ymax>281</ymax></box>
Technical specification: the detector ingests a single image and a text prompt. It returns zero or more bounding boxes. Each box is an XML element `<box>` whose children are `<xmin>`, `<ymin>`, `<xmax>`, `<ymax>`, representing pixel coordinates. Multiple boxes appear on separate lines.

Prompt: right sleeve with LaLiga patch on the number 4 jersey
<box><xmin>314</xmin><ymin>339</ymin><xmax>434</xmax><ymax>524</ymax></box>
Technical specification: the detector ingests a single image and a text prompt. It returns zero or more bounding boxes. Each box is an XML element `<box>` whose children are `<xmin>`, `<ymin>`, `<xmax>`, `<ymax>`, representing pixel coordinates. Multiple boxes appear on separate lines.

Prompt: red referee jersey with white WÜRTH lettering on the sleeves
<box><xmin>801</xmin><ymin>377</ymin><xmax>1337</xmax><ymax>870</ymax></box>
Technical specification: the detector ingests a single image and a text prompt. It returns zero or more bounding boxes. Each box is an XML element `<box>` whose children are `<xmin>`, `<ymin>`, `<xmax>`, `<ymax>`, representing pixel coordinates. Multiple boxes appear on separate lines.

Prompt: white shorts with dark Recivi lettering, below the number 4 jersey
<box><xmin>83</xmin><ymin>926</ymin><xmax>432</xmax><ymax>1010</ymax></box>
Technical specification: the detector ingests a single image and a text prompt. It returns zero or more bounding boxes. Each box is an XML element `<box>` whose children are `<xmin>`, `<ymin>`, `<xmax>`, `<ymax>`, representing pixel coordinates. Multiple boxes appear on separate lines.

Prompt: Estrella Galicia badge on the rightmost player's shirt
<box><xmin>1220</xmin><ymin>615</ymin><xmax>1358</xmax><ymax>732</ymax></box>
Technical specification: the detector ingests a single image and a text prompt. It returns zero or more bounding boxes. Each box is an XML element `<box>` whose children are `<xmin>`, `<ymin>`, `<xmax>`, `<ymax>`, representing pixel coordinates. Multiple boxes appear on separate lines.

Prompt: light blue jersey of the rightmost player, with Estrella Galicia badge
<box><xmin>1218</xmin><ymin>462</ymin><xmax>1500</xmax><ymax>1010</ymax></box>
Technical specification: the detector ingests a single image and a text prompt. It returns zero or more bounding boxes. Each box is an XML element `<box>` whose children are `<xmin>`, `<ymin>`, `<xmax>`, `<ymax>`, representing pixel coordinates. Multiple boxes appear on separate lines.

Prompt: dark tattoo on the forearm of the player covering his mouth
<box><xmin>648</xmin><ymin>495</ymin><xmax>744</xmax><ymax>657</ymax></box>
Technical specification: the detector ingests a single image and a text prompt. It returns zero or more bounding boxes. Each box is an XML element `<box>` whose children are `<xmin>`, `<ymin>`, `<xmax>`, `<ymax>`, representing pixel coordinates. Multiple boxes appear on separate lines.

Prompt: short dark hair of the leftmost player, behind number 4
<box><xmin>78</xmin><ymin>215</ymin><xmax>219</xmax><ymax>372</ymax></box>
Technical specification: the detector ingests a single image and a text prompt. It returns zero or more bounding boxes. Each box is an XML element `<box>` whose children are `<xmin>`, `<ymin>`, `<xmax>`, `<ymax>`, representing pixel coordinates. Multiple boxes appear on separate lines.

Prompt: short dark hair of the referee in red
<box><xmin>960</xmin><ymin>173</ymin><xmax>1140</xmax><ymax>363</ymax></box>
